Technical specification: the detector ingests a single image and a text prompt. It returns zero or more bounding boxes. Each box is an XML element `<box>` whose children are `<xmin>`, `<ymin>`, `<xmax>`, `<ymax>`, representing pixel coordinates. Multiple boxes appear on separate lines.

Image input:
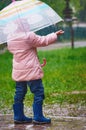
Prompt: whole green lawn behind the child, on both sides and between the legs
<box><xmin>0</xmin><ymin>47</ymin><xmax>86</xmax><ymax>109</ymax></box>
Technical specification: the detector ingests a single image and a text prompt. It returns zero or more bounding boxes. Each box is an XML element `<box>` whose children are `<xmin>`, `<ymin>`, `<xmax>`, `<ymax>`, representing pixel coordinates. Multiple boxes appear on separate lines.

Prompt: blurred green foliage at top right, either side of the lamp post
<box><xmin>42</xmin><ymin>0</ymin><xmax>86</xmax><ymax>21</ymax></box>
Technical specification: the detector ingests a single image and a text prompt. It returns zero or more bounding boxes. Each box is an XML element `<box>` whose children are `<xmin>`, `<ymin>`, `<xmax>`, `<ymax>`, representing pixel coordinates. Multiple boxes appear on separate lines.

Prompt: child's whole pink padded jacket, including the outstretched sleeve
<box><xmin>8</xmin><ymin>32</ymin><xmax>57</xmax><ymax>81</ymax></box>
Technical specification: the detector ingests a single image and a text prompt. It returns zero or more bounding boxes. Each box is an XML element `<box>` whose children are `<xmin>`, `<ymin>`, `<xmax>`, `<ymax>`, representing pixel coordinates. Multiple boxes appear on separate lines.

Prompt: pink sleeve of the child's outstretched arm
<box><xmin>30</xmin><ymin>33</ymin><xmax>57</xmax><ymax>47</ymax></box>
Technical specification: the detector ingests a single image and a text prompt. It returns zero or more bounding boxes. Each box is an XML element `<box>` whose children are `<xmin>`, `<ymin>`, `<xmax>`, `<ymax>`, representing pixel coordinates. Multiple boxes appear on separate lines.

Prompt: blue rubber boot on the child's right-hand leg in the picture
<box><xmin>33</xmin><ymin>103</ymin><xmax>51</xmax><ymax>124</ymax></box>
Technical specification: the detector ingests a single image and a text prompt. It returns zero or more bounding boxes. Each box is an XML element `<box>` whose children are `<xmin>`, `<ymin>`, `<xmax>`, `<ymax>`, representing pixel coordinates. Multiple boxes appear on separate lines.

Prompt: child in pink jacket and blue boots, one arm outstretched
<box><xmin>7</xmin><ymin>21</ymin><xmax>64</xmax><ymax>124</ymax></box>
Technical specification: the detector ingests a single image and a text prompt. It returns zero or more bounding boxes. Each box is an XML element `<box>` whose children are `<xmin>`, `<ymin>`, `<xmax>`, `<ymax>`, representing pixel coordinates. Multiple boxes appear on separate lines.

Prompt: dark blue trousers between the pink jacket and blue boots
<box><xmin>14</xmin><ymin>79</ymin><xmax>44</xmax><ymax>103</ymax></box>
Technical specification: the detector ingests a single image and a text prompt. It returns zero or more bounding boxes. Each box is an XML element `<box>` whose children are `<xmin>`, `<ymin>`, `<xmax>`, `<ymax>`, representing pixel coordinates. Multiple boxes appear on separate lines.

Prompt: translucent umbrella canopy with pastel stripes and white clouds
<box><xmin>0</xmin><ymin>0</ymin><xmax>62</xmax><ymax>44</ymax></box>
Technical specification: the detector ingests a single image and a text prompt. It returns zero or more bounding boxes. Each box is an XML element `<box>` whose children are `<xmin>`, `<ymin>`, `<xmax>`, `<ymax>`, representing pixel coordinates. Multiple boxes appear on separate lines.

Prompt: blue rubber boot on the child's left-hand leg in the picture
<box><xmin>13</xmin><ymin>103</ymin><xmax>32</xmax><ymax>124</ymax></box>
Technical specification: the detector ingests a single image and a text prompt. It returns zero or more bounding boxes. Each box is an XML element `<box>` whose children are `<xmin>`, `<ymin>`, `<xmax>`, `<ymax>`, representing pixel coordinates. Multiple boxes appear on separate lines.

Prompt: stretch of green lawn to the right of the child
<box><xmin>39</xmin><ymin>48</ymin><xmax>86</xmax><ymax>103</ymax></box>
